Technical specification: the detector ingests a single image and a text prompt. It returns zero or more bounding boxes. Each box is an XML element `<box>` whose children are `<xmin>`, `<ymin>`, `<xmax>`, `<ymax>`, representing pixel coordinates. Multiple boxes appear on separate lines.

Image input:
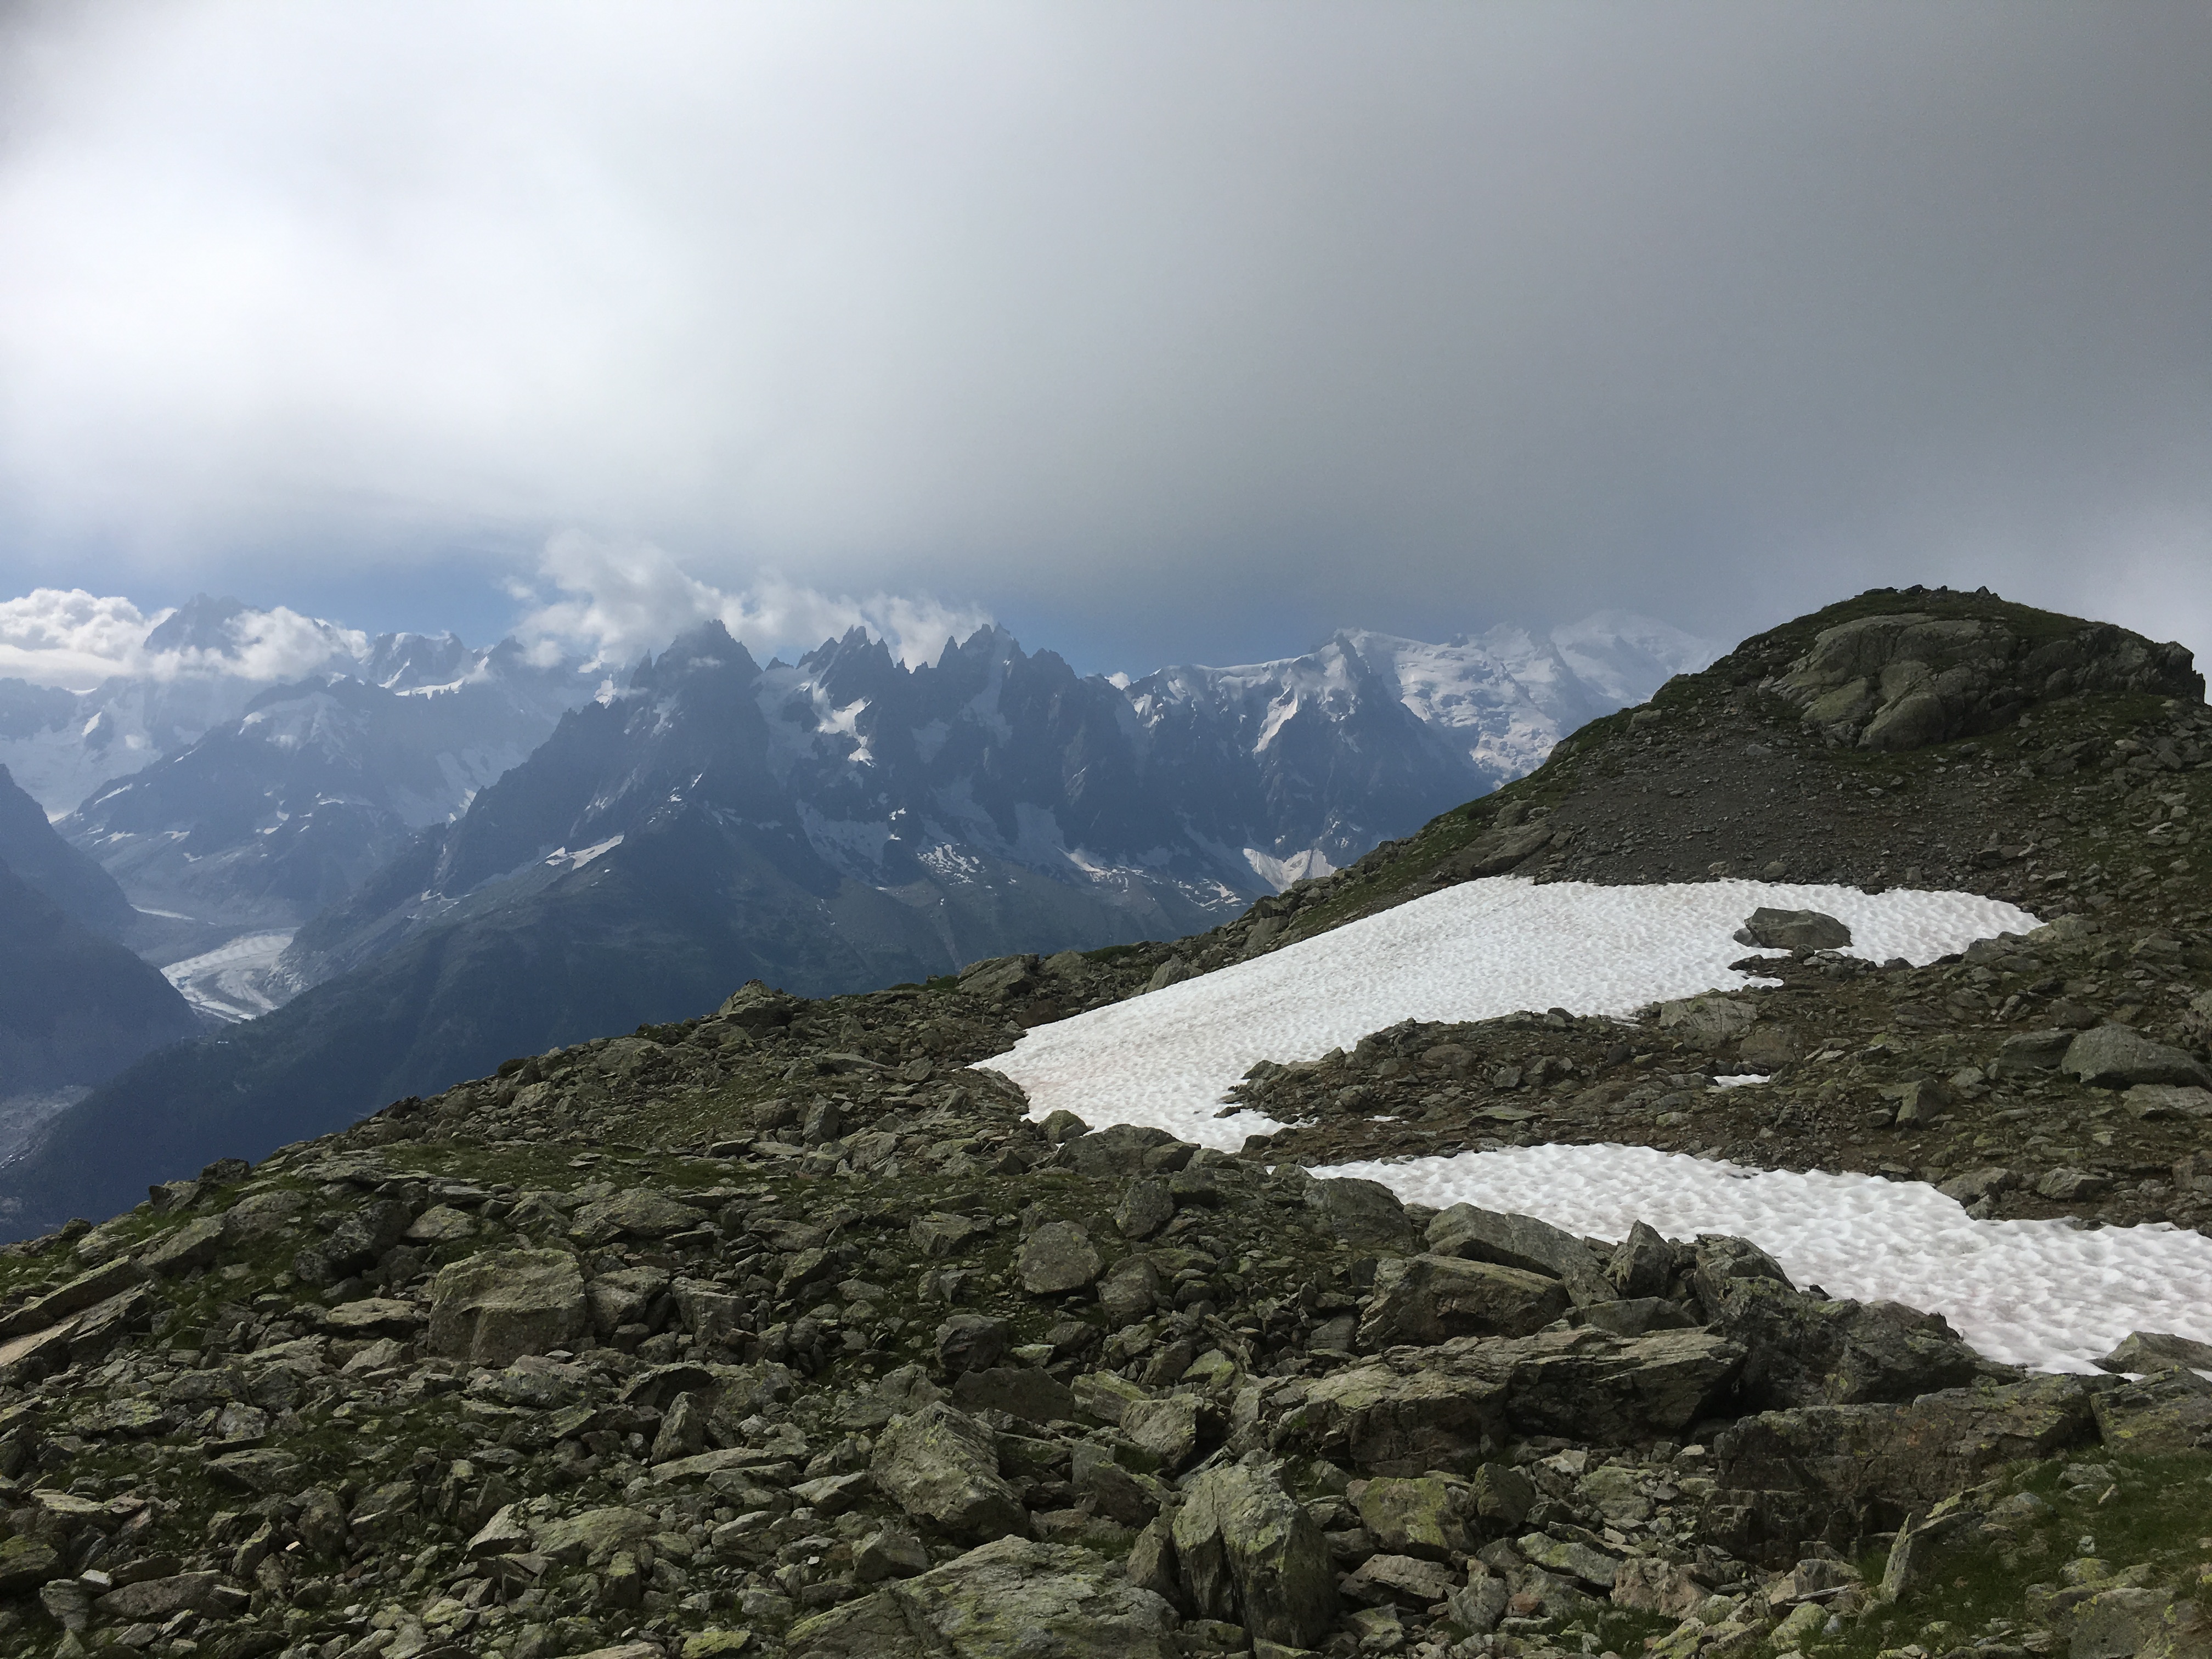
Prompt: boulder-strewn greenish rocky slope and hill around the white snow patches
<box><xmin>0</xmin><ymin>593</ymin><xmax>2212</xmax><ymax>1659</ymax></box>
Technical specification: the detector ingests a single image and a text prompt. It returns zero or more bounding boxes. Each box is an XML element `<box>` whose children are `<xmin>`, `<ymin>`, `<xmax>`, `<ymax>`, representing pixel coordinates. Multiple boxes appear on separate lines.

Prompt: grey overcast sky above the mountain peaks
<box><xmin>0</xmin><ymin>0</ymin><xmax>2212</xmax><ymax>670</ymax></box>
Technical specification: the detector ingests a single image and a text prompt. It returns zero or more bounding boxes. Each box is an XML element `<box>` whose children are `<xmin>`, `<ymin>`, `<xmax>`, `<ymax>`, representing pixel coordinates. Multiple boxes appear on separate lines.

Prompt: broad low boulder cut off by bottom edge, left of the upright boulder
<box><xmin>785</xmin><ymin>1537</ymin><xmax>1181</xmax><ymax>1659</ymax></box>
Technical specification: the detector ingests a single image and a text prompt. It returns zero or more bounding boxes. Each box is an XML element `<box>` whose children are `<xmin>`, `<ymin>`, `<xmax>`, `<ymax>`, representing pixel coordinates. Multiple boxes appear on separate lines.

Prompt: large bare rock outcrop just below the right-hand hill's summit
<box><xmin>1776</xmin><ymin>611</ymin><xmax>2205</xmax><ymax>750</ymax></box>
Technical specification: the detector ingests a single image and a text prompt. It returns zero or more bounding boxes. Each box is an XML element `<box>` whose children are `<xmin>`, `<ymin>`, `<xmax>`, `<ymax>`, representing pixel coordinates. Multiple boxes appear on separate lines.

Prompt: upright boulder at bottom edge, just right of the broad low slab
<box><xmin>1175</xmin><ymin>1458</ymin><xmax>1336</xmax><ymax>1648</ymax></box>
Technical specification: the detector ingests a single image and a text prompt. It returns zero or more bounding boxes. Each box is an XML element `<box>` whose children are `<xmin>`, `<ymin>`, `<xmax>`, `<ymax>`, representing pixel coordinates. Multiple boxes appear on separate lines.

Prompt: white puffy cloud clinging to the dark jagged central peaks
<box><xmin>515</xmin><ymin>531</ymin><xmax>991</xmax><ymax>668</ymax></box>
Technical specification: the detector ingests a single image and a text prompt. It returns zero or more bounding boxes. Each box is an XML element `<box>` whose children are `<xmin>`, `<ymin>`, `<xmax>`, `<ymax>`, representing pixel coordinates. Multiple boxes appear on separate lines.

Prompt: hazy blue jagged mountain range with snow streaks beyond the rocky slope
<box><xmin>0</xmin><ymin>601</ymin><xmax>1710</xmax><ymax>1238</ymax></box>
